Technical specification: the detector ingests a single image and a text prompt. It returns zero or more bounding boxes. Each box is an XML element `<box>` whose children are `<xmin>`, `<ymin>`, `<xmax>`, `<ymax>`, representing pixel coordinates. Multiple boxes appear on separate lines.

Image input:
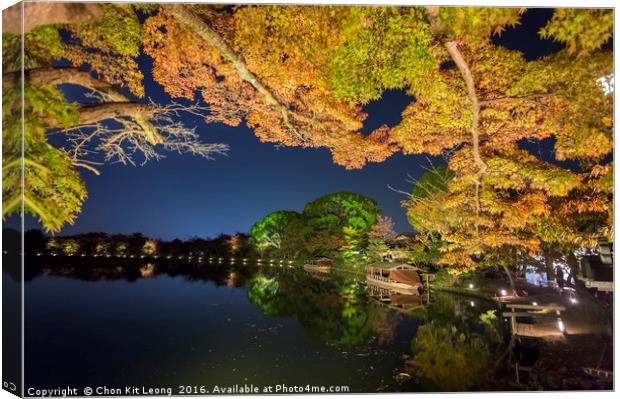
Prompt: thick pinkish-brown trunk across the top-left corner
<box><xmin>2</xmin><ymin>2</ymin><xmax>103</xmax><ymax>35</ymax></box>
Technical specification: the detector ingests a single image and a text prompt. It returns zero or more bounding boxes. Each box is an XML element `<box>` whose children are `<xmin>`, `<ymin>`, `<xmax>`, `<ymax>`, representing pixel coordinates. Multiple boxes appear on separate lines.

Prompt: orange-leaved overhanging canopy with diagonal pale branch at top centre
<box><xmin>144</xmin><ymin>5</ymin><xmax>393</xmax><ymax>167</ymax></box>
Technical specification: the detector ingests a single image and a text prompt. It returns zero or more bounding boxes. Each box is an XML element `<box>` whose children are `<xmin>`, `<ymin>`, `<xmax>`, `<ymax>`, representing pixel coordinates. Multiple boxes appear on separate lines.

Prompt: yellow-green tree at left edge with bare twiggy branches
<box><xmin>2</xmin><ymin>3</ymin><xmax>227</xmax><ymax>232</ymax></box>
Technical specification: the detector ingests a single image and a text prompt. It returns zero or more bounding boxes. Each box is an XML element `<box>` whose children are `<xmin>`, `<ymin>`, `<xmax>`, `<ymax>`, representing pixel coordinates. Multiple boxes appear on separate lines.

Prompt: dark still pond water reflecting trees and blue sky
<box><xmin>18</xmin><ymin>264</ymin><xmax>499</xmax><ymax>394</ymax></box>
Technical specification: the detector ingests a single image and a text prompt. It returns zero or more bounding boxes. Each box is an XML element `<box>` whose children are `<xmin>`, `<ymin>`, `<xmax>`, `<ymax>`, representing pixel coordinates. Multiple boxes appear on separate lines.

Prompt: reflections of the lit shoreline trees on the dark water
<box><xmin>25</xmin><ymin>259</ymin><xmax>505</xmax><ymax>391</ymax></box>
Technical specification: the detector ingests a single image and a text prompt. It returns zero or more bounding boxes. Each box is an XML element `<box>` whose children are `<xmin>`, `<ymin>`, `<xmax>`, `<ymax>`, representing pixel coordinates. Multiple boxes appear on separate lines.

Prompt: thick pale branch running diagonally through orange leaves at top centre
<box><xmin>163</xmin><ymin>4</ymin><xmax>300</xmax><ymax>138</ymax></box>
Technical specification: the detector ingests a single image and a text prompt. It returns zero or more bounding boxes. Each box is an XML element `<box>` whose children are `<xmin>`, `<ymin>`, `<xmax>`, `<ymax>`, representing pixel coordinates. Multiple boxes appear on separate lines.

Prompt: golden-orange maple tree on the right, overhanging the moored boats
<box><xmin>376</xmin><ymin>7</ymin><xmax>613</xmax><ymax>272</ymax></box>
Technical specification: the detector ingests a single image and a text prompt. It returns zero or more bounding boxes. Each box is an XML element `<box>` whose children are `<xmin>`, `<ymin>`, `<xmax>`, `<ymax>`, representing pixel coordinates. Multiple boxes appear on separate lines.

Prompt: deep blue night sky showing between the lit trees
<box><xmin>17</xmin><ymin>9</ymin><xmax>572</xmax><ymax>239</ymax></box>
